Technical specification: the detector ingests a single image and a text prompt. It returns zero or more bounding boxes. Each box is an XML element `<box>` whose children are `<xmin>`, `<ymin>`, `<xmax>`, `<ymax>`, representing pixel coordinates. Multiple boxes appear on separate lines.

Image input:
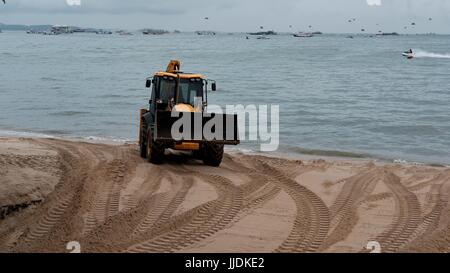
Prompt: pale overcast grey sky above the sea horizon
<box><xmin>0</xmin><ymin>0</ymin><xmax>450</xmax><ymax>33</ymax></box>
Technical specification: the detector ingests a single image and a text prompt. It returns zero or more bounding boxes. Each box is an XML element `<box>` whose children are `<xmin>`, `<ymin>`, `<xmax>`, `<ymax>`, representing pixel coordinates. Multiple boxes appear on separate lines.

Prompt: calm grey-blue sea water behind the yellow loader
<box><xmin>0</xmin><ymin>32</ymin><xmax>450</xmax><ymax>164</ymax></box>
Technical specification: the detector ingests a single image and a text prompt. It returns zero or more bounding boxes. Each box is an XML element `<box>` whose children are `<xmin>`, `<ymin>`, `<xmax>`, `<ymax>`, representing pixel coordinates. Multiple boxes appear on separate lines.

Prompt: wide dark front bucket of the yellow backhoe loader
<box><xmin>154</xmin><ymin>111</ymin><xmax>240</xmax><ymax>145</ymax></box>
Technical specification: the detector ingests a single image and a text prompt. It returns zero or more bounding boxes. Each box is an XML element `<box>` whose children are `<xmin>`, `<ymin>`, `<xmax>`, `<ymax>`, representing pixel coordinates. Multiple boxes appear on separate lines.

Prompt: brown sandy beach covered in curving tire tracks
<box><xmin>0</xmin><ymin>138</ymin><xmax>450</xmax><ymax>253</ymax></box>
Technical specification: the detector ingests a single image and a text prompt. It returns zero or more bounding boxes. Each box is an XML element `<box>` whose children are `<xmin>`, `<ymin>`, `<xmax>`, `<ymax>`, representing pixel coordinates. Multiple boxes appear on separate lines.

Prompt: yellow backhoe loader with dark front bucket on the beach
<box><xmin>139</xmin><ymin>61</ymin><xmax>240</xmax><ymax>167</ymax></box>
